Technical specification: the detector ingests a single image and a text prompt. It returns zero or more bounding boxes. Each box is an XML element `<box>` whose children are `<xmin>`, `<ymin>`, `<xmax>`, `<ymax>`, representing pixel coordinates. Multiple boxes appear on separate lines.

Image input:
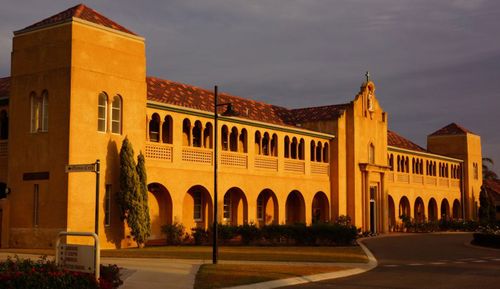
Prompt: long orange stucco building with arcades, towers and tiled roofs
<box><xmin>0</xmin><ymin>5</ymin><xmax>482</xmax><ymax>248</ymax></box>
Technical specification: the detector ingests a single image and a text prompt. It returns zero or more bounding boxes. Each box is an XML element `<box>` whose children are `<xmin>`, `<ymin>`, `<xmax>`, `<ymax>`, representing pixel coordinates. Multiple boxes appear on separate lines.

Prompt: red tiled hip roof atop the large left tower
<box><xmin>16</xmin><ymin>4</ymin><xmax>137</xmax><ymax>35</ymax></box>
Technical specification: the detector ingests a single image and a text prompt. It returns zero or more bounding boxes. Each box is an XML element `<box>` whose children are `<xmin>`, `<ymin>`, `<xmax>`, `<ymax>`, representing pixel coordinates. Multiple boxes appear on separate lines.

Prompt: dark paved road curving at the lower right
<box><xmin>283</xmin><ymin>234</ymin><xmax>500</xmax><ymax>289</ymax></box>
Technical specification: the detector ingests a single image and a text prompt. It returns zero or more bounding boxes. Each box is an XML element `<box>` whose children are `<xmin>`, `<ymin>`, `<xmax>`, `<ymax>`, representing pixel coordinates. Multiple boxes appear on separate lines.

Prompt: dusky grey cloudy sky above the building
<box><xmin>0</xmin><ymin>0</ymin><xmax>500</xmax><ymax>174</ymax></box>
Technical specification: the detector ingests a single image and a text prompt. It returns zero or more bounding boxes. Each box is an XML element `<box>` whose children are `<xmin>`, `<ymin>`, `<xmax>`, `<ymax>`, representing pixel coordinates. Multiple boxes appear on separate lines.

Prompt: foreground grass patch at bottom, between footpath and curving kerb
<box><xmin>194</xmin><ymin>264</ymin><xmax>345</xmax><ymax>289</ymax></box>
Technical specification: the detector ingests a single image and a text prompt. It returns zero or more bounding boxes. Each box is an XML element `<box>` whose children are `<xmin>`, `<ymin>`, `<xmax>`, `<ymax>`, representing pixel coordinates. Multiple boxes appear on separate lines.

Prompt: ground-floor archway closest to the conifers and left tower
<box><xmin>148</xmin><ymin>183</ymin><xmax>172</xmax><ymax>240</ymax></box>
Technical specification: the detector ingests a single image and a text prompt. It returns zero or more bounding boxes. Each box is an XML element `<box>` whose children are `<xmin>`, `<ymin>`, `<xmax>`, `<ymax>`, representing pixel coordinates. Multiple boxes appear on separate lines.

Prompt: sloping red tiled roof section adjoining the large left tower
<box><xmin>146</xmin><ymin>77</ymin><xmax>292</xmax><ymax>125</ymax></box>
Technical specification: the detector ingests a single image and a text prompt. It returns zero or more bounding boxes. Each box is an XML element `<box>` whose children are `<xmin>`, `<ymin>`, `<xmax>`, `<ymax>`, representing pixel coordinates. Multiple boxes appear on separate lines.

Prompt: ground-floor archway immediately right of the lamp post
<box><xmin>222</xmin><ymin>187</ymin><xmax>248</xmax><ymax>226</ymax></box>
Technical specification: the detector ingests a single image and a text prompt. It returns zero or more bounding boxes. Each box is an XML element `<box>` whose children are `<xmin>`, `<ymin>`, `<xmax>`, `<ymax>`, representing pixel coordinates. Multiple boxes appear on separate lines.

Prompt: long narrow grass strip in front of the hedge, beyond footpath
<box><xmin>101</xmin><ymin>246</ymin><xmax>368</xmax><ymax>263</ymax></box>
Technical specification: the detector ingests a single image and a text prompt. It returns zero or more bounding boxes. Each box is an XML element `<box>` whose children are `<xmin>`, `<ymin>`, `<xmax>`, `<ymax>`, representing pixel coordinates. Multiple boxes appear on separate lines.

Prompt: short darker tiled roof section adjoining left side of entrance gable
<box><xmin>287</xmin><ymin>103</ymin><xmax>349</xmax><ymax>123</ymax></box>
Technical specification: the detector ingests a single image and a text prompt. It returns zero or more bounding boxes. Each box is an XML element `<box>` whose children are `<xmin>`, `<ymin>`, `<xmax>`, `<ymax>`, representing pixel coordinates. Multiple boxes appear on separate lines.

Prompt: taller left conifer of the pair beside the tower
<box><xmin>118</xmin><ymin>137</ymin><xmax>150</xmax><ymax>247</ymax></box>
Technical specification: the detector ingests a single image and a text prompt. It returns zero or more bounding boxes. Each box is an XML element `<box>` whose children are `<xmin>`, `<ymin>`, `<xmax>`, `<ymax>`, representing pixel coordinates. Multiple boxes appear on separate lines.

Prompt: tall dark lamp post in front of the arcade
<box><xmin>212</xmin><ymin>85</ymin><xmax>237</xmax><ymax>264</ymax></box>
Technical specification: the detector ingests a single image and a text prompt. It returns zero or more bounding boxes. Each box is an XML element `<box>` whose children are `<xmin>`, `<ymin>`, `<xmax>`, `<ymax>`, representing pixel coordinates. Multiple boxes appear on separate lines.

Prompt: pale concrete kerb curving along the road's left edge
<box><xmin>219</xmin><ymin>238</ymin><xmax>378</xmax><ymax>289</ymax></box>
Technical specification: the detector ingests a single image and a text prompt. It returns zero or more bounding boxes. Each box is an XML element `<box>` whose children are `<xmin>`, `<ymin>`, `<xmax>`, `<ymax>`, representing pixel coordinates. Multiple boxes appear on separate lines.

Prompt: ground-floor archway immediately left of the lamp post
<box><xmin>182</xmin><ymin>185</ymin><xmax>213</xmax><ymax>230</ymax></box>
